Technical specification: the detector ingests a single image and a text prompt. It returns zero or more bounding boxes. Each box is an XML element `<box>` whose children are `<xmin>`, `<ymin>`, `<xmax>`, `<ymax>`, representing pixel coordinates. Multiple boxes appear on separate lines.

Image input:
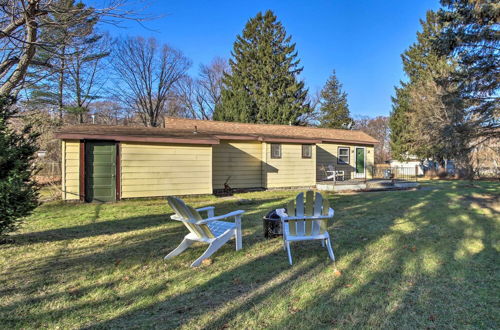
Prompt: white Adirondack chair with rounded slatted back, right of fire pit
<box><xmin>277</xmin><ymin>190</ymin><xmax>335</xmax><ymax>265</ymax></box>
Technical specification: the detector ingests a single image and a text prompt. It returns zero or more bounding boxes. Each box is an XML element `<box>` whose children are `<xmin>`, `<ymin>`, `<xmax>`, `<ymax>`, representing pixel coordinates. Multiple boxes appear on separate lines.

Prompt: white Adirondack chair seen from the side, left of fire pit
<box><xmin>165</xmin><ymin>196</ymin><xmax>245</xmax><ymax>267</ymax></box>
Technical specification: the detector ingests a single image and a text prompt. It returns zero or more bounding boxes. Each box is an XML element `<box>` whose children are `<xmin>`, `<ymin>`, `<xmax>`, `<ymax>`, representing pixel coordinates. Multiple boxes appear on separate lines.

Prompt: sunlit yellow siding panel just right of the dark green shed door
<box><xmin>121</xmin><ymin>142</ymin><xmax>212</xmax><ymax>198</ymax></box>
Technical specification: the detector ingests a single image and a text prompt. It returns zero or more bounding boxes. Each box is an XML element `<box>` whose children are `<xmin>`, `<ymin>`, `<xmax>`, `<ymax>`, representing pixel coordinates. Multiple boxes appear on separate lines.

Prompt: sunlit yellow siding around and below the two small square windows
<box><xmin>264</xmin><ymin>143</ymin><xmax>316</xmax><ymax>188</ymax></box>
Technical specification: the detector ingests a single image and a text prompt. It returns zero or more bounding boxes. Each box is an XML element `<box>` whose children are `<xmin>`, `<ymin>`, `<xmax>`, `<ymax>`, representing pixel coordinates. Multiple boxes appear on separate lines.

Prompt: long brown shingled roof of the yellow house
<box><xmin>52</xmin><ymin>117</ymin><xmax>378</xmax><ymax>145</ymax></box>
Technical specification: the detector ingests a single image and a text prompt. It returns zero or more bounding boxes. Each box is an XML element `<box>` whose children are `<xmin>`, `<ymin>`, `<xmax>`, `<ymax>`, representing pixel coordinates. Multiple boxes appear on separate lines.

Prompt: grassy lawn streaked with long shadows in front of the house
<box><xmin>0</xmin><ymin>181</ymin><xmax>500</xmax><ymax>329</ymax></box>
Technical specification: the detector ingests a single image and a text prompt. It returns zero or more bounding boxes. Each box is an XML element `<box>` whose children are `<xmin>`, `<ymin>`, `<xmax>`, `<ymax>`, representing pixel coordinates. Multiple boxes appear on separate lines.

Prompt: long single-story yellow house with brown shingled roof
<box><xmin>56</xmin><ymin>118</ymin><xmax>377</xmax><ymax>201</ymax></box>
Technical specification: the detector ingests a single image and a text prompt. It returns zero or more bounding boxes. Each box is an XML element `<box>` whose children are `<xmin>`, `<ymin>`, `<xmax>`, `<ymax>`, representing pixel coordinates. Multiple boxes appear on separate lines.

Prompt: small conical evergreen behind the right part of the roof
<box><xmin>319</xmin><ymin>71</ymin><xmax>354</xmax><ymax>129</ymax></box>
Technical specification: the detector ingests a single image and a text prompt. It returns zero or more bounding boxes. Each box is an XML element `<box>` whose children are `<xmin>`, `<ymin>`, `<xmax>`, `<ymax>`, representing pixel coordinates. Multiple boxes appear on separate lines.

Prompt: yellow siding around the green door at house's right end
<box><xmin>316</xmin><ymin>143</ymin><xmax>374</xmax><ymax>180</ymax></box>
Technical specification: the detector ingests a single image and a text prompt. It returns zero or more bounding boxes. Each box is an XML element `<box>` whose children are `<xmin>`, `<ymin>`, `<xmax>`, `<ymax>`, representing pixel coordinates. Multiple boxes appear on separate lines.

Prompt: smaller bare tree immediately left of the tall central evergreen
<box><xmin>177</xmin><ymin>57</ymin><xmax>230</xmax><ymax>119</ymax></box>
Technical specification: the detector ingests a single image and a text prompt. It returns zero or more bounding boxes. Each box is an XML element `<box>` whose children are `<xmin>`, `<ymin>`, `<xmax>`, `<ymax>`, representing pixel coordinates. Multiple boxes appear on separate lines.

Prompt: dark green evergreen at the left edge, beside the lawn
<box><xmin>0</xmin><ymin>96</ymin><xmax>38</xmax><ymax>236</ymax></box>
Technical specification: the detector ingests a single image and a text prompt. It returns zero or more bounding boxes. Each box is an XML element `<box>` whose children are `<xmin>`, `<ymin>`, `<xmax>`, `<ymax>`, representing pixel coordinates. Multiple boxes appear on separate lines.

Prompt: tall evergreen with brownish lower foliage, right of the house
<box><xmin>390</xmin><ymin>11</ymin><xmax>472</xmax><ymax>176</ymax></box>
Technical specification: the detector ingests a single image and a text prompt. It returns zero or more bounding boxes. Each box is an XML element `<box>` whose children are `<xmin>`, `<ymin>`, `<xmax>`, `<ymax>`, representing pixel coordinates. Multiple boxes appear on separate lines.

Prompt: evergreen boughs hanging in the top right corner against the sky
<box><xmin>434</xmin><ymin>0</ymin><xmax>500</xmax><ymax>131</ymax></box>
